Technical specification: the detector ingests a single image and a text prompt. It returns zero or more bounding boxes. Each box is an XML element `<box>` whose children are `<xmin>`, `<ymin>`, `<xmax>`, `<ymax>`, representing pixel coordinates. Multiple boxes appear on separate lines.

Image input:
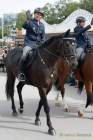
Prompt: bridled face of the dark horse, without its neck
<box><xmin>60</xmin><ymin>37</ymin><xmax>78</xmax><ymax>69</ymax></box>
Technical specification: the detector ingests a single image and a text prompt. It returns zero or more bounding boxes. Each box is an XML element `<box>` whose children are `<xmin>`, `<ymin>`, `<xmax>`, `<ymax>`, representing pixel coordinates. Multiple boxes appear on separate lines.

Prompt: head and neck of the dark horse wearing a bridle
<box><xmin>42</xmin><ymin>30</ymin><xmax>77</xmax><ymax>70</ymax></box>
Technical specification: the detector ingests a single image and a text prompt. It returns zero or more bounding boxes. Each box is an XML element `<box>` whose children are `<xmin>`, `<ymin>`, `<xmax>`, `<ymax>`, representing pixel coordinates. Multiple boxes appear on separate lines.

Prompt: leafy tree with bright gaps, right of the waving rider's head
<box><xmin>43</xmin><ymin>0</ymin><xmax>79</xmax><ymax>24</ymax></box>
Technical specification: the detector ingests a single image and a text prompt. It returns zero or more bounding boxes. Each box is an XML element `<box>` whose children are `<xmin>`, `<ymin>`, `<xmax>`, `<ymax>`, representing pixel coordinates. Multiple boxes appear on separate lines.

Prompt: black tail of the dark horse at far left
<box><xmin>6</xmin><ymin>71</ymin><xmax>16</xmax><ymax>100</ymax></box>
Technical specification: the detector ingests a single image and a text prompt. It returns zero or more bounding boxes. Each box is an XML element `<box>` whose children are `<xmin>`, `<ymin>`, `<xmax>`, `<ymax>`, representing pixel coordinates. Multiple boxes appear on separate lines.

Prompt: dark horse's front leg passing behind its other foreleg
<box><xmin>35</xmin><ymin>87</ymin><xmax>51</xmax><ymax>126</ymax></box>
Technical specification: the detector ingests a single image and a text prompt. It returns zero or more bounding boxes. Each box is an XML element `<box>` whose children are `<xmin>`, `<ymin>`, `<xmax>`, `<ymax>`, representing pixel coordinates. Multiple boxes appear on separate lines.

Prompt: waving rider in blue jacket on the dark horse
<box><xmin>18</xmin><ymin>8</ymin><xmax>45</xmax><ymax>81</ymax></box>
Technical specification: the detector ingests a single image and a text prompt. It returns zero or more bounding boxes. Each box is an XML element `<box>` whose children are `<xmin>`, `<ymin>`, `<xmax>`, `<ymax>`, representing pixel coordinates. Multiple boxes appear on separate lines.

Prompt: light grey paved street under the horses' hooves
<box><xmin>0</xmin><ymin>73</ymin><xmax>93</xmax><ymax>140</ymax></box>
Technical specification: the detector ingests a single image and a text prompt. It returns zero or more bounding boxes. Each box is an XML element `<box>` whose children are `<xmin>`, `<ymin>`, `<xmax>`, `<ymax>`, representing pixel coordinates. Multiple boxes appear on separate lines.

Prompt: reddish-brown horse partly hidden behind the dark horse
<box><xmin>57</xmin><ymin>47</ymin><xmax>93</xmax><ymax>116</ymax></box>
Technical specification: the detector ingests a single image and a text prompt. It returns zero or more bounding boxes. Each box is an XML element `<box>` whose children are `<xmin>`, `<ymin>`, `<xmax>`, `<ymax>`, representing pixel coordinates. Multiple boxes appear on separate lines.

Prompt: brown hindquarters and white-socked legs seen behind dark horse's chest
<box><xmin>55</xmin><ymin>59</ymin><xmax>71</xmax><ymax>112</ymax></box>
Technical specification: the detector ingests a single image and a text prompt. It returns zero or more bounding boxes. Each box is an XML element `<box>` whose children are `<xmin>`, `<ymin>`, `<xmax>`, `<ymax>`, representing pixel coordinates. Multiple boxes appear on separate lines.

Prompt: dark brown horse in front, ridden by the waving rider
<box><xmin>6</xmin><ymin>30</ymin><xmax>77</xmax><ymax>135</ymax></box>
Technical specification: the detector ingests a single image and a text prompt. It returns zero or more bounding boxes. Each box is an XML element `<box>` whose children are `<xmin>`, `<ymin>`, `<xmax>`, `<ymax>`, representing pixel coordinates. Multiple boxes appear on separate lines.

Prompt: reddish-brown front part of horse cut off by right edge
<box><xmin>76</xmin><ymin>47</ymin><xmax>93</xmax><ymax>116</ymax></box>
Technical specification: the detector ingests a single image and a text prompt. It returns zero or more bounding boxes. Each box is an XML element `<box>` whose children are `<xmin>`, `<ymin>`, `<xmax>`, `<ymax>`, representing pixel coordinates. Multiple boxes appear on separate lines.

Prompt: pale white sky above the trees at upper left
<box><xmin>0</xmin><ymin>0</ymin><xmax>78</xmax><ymax>14</ymax></box>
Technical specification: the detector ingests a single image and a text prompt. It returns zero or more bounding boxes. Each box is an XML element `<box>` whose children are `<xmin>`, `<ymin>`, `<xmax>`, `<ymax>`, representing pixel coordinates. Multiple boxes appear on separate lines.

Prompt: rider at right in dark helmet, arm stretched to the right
<box><xmin>74</xmin><ymin>17</ymin><xmax>92</xmax><ymax>60</ymax></box>
